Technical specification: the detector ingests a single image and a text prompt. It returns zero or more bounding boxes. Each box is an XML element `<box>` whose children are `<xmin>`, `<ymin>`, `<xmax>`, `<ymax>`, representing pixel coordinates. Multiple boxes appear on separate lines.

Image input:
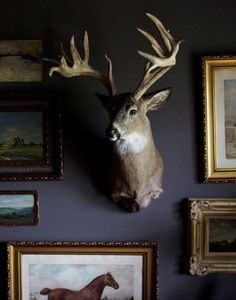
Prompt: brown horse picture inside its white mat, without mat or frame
<box><xmin>29</xmin><ymin>260</ymin><xmax>134</xmax><ymax>300</ymax></box>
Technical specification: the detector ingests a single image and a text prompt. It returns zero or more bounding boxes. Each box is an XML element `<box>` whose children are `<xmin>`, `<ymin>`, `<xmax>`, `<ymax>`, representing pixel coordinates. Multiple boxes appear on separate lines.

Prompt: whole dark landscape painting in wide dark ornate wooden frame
<box><xmin>0</xmin><ymin>92</ymin><xmax>63</xmax><ymax>181</ymax></box>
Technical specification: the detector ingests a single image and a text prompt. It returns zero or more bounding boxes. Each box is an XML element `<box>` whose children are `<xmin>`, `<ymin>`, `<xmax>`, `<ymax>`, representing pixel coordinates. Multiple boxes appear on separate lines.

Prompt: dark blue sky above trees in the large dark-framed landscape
<box><xmin>0</xmin><ymin>112</ymin><xmax>43</xmax><ymax>144</ymax></box>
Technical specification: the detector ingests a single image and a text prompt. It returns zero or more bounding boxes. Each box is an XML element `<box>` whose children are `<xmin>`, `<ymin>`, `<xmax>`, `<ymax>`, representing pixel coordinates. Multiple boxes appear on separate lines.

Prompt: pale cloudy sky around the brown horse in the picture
<box><xmin>29</xmin><ymin>262</ymin><xmax>134</xmax><ymax>299</ymax></box>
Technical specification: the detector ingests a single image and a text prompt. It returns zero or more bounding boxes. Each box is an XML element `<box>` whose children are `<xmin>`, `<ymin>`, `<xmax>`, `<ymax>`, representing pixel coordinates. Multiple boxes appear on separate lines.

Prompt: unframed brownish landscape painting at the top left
<box><xmin>0</xmin><ymin>40</ymin><xmax>42</xmax><ymax>82</ymax></box>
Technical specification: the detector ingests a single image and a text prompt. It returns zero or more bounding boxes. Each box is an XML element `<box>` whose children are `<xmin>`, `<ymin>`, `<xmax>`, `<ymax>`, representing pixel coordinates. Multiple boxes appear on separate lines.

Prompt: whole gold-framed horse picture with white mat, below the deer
<box><xmin>8</xmin><ymin>242</ymin><xmax>158</xmax><ymax>300</ymax></box>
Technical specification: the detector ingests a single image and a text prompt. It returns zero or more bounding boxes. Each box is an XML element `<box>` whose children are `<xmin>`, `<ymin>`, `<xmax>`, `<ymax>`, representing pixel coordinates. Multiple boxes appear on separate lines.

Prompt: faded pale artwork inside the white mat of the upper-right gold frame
<box><xmin>224</xmin><ymin>79</ymin><xmax>236</xmax><ymax>159</ymax></box>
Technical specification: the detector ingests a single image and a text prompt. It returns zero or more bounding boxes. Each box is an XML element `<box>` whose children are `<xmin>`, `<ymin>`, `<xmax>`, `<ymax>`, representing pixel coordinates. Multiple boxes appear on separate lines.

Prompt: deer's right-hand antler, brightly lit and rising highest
<box><xmin>133</xmin><ymin>13</ymin><xmax>183</xmax><ymax>100</ymax></box>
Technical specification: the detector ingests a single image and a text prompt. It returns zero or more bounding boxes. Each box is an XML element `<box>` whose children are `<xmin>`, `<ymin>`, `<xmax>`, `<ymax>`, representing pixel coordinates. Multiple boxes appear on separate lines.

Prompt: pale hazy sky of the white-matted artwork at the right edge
<box><xmin>224</xmin><ymin>80</ymin><xmax>236</xmax><ymax>120</ymax></box>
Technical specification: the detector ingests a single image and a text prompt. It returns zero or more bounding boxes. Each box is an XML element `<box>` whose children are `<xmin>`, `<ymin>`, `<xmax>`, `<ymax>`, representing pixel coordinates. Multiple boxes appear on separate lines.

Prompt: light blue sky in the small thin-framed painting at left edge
<box><xmin>0</xmin><ymin>195</ymin><xmax>34</xmax><ymax>208</ymax></box>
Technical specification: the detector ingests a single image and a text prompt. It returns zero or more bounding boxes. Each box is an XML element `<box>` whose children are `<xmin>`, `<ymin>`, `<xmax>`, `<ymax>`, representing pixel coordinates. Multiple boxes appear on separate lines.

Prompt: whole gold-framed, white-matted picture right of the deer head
<box><xmin>203</xmin><ymin>56</ymin><xmax>236</xmax><ymax>182</ymax></box>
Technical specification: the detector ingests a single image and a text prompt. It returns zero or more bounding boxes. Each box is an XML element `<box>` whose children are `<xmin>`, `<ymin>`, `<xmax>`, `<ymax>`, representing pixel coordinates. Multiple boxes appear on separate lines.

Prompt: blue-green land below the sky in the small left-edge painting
<box><xmin>0</xmin><ymin>207</ymin><xmax>34</xmax><ymax>223</ymax></box>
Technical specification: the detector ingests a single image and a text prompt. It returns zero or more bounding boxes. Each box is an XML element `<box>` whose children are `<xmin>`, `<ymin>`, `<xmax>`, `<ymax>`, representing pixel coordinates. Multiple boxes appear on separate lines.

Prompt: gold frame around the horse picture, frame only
<box><xmin>7</xmin><ymin>242</ymin><xmax>158</xmax><ymax>300</ymax></box>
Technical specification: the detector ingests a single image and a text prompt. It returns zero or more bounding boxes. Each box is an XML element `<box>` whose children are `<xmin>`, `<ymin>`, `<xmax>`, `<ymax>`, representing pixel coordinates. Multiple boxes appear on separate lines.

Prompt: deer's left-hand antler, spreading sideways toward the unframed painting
<box><xmin>49</xmin><ymin>31</ymin><xmax>116</xmax><ymax>96</ymax></box>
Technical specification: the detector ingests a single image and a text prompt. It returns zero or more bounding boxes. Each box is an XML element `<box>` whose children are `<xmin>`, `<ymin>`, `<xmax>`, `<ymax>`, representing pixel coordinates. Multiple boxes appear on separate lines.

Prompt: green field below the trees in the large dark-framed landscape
<box><xmin>0</xmin><ymin>144</ymin><xmax>43</xmax><ymax>160</ymax></box>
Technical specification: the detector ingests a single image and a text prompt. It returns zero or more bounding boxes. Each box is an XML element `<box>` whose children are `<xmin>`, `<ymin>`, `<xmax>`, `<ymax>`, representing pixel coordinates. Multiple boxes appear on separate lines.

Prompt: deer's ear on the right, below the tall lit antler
<box><xmin>143</xmin><ymin>88</ymin><xmax>171</xmax><ymax>111</ymax></box>
